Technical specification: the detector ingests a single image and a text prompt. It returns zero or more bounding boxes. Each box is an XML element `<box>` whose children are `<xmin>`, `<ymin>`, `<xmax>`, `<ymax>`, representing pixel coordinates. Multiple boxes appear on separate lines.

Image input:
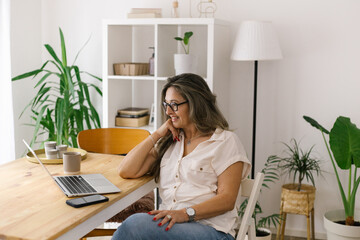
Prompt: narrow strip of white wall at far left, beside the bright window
<box><xmin>10</xmin><ymin>0</ymin><xmax>42</xmax><ymax>158</ymax></box>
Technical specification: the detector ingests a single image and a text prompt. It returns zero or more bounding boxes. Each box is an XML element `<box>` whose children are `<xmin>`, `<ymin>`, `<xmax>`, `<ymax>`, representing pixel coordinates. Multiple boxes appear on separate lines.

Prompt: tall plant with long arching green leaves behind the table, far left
<box><xmin>12</xmin><ymin>28</ymin><xmax>102</xmax><ymax>147</ymax></box>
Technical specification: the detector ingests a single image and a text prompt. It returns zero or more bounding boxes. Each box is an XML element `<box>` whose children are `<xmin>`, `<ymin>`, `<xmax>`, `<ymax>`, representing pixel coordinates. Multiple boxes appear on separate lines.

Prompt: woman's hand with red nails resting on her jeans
<box><xmin>148</xmin><ymin>209</ymin><xmax>189</xmax><ymax>231</ymax></box>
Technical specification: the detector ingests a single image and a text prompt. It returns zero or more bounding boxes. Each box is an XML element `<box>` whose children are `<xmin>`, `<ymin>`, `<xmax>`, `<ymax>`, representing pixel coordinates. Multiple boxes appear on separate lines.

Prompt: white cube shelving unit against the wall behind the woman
<box><xmin>102</xmin><ymin>18</ymin><xmax>230</xmax><ymax>132</ymax></box>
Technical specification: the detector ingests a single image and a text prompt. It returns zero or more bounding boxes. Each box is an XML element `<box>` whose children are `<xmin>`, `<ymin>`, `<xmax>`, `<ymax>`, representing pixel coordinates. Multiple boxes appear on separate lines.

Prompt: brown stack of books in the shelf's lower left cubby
<box><xmin>115</xmin><ymin>107</ymin><xmax>149</xmax><ymax>127</ymax></box>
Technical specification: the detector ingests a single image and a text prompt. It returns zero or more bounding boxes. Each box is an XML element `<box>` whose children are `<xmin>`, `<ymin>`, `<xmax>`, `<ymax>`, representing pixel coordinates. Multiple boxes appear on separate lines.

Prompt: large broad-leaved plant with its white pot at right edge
<box><xmin>304</xmin><ymin>116</ymin><xmax>360</xmax><ymax>240</ymax></box>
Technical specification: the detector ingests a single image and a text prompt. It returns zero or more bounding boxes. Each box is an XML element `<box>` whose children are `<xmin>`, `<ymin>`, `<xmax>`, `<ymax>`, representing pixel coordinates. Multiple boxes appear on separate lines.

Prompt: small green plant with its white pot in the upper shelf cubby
<box><xmin>174</xmin><ymin>32</ymin><xmax>197</xmax><ymax>75</ymax></box>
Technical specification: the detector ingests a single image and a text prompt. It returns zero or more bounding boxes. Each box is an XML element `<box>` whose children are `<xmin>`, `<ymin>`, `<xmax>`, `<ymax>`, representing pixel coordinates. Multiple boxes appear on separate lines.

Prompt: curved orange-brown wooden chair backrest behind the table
<box><xmin>77</xmin><ymin>128</ymin><xmax>150</xmax><ymax>154</ymax></box>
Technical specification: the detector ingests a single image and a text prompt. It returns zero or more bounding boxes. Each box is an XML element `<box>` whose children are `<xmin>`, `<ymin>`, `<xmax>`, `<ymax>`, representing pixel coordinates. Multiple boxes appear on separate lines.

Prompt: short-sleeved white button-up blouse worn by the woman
<box><xmin>159</xmin><ymin>129</ymin><xmax>251</xmax><ymax>236</ymax></box>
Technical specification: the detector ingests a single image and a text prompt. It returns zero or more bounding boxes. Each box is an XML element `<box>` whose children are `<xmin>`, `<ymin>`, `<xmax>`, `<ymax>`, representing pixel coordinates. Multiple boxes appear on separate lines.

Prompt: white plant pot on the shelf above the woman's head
<box><xmin>174</xmin><ymin>54</ymin><xmax>198</xmax><ymax>75</ymax></box>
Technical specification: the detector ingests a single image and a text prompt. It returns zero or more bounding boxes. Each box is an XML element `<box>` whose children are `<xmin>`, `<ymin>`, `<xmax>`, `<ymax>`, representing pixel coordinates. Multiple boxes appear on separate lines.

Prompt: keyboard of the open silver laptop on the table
<box><xmin>58</xmin><ymin>176</ymin><xmax>96</xmax><ymax>194</ymax></box>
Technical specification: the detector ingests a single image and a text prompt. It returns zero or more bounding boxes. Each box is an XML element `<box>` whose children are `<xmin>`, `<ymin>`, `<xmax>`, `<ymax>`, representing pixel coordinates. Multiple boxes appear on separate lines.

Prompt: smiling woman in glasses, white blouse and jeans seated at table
<box><xmin>113</xmin><ymin>74</ymin><xmax>250</xmax><ymax>240</ymax></box>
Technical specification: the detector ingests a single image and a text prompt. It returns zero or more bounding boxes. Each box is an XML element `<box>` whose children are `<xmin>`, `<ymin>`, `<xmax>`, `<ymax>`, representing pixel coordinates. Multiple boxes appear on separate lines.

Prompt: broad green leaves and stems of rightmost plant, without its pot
<box><xmin>304</xmin><ymin>116</ymin><xmax>360</xmax><ymax>225</ymax></box>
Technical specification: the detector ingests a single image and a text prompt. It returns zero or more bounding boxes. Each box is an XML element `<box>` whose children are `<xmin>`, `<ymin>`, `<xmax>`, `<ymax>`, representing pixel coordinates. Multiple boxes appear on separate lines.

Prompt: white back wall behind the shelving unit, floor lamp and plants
<box><xmin>12</xmin><ymin>0</ymin><xmax>360</xmax><ymax>237</ymax></box>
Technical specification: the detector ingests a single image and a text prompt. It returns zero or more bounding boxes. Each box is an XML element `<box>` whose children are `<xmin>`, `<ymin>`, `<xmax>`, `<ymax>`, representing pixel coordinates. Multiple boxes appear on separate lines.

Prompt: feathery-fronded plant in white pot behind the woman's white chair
<box><xmin>239</xmin><ymin>155</ymin><xmax>280</xmax><ymax>240</ymax></box>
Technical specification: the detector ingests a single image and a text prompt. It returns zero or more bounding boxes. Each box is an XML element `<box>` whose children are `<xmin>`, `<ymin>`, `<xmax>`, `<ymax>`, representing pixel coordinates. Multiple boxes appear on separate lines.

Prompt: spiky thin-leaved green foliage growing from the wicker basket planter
<box><xmin>277</xmin><ymin>139</ymin><xmax>321</xmax><ymax>191</ymax></box>
